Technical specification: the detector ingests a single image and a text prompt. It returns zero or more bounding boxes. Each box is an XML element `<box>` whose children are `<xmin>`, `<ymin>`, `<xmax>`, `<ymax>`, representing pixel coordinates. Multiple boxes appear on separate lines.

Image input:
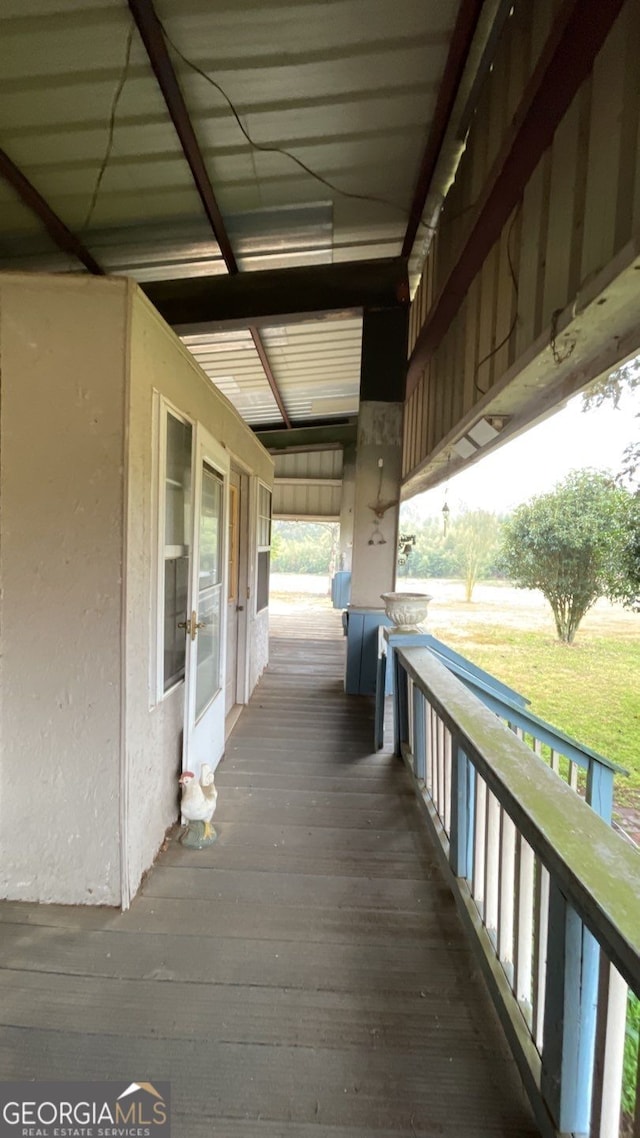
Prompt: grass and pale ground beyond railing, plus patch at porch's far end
<box><xmin>272</xmin><ymin>577</ymin><xmax>640</xmax><ymax>811</ymax></box>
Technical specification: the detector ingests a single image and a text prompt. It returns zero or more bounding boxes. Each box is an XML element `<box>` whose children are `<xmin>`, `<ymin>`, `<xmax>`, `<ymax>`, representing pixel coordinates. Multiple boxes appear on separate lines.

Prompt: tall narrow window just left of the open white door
<box><xmin>163</xmin><ymin>411</ymin><xmax>192</xmax><ymax>692</ymax></box>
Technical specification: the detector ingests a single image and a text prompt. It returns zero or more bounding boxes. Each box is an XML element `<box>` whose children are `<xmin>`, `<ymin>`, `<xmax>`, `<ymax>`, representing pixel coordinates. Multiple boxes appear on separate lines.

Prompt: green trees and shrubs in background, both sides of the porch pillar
<box><xmin>271</xmin><ymin>470</ymin><xmax>640</xmax><ymax>644</ymax></box>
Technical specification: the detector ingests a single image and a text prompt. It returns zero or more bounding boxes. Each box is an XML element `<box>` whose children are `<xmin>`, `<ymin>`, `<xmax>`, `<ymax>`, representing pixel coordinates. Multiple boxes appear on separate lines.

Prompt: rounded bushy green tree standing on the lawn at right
<box><xmin>502</xmin><ymin>470</ymin><xmax>638</xmax><ymax>644</ymax></box>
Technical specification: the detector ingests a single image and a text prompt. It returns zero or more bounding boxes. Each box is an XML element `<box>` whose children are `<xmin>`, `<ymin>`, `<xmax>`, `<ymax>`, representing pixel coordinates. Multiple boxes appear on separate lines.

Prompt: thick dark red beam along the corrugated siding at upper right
<box><xmin>408</xmin><ymin>0</ymin><xmax>624</xmax><ymax>393</ymax></box>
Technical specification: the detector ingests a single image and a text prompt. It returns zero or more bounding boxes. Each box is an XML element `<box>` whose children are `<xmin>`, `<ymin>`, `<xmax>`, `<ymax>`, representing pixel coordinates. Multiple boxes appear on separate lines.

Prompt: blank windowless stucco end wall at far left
<box><xmin>0</xmin><ymin>274</ymin><xmax>126</xmax><ymax>905</ymax></box>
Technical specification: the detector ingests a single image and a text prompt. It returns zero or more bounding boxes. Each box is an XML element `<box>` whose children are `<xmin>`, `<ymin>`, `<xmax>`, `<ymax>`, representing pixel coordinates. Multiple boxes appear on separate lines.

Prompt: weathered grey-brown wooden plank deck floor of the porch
<box><xmin>0</xmin><ymin>638</ymin><xmax>536</xmax><ymax>1138</ymax></box>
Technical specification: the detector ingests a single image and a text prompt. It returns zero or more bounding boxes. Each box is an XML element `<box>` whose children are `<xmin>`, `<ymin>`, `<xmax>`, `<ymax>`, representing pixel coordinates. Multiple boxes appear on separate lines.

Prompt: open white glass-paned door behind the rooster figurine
<box><xmin>182</xmin><ymin>427</ymin><xmax>229</xmax><ymax>777</ymax></box>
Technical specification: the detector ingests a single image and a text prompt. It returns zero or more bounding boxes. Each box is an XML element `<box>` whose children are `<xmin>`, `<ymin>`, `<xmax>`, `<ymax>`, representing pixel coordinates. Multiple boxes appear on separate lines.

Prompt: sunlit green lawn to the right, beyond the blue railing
<box><xmin>436</xmin><ymin>624</ymin><xmax>640</xmax><ymax>805</ymax></box>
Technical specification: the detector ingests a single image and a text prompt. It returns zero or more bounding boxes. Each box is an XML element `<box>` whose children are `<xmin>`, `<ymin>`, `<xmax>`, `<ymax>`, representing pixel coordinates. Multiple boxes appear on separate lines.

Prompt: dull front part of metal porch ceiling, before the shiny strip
<box><xmin>0</xmin><ymin>0</ymin><xmax>458</xmax><ymax>272</ymax></box>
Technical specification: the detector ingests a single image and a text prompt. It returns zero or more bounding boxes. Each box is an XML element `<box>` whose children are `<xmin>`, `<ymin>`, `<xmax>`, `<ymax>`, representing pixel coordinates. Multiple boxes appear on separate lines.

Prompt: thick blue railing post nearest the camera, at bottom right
<box><xmin>541</xmin><ymin>880</ymin><xmax>600</xmax><ymax>1135</ymax></box>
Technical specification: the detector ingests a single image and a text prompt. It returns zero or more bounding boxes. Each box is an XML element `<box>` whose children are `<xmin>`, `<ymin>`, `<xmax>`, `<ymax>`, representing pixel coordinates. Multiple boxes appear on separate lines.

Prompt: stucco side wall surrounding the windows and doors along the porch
<box><xmin>125</xmin><ymin>287</ymin><xmax>273</xmax><ymax>896</ymax></box>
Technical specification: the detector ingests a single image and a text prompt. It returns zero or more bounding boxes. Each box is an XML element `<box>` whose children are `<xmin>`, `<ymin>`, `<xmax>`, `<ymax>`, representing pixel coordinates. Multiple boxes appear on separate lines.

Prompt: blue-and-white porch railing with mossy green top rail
<box><xmin>394</xmin><ymin>645</ymin><xmax>640</xmax><ymax>1138</ymax></box>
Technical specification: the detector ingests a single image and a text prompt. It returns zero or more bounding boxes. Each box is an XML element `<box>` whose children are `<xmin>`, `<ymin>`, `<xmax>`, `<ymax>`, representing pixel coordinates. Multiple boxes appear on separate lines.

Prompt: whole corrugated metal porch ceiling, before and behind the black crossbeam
<box><xmin>0</xmin><ymin>0</ymin><xmax>478</xmax><ymax>426</ymax></box>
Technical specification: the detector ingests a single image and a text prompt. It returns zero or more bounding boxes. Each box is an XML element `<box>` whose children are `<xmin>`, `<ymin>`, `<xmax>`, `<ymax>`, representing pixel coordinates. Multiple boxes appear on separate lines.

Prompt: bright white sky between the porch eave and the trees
<box><xmin>407</xmin><ymin>387</ymin><xmax>640</xmax><ymax>518</ymax></box>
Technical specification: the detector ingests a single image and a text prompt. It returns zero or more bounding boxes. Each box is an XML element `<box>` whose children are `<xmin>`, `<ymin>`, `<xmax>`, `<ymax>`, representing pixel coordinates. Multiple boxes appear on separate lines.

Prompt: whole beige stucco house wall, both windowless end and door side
<box><xmin>0</xmin><ymin>274</ymin><xmax>273</xmax><ymax>905</ymax></box>
